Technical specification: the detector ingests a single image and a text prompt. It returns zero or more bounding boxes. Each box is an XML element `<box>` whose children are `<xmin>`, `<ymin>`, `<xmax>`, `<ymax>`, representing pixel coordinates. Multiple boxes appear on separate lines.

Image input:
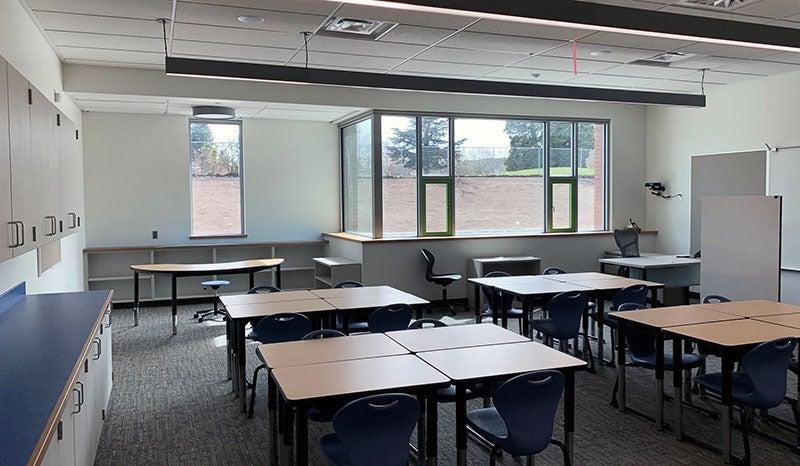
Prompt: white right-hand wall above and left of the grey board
<box><xmin>647</xmin><ymin>73</ymin><xmax>800</xmax><ymax>253</ymax></box>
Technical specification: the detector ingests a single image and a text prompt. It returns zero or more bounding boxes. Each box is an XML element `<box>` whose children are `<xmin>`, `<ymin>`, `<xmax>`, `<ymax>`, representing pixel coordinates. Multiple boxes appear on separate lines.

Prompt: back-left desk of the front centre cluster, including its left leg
<box><xmin>257</xmin><ymin>333</ymin><xmax>408</xmax><ymax>464</ymax></box>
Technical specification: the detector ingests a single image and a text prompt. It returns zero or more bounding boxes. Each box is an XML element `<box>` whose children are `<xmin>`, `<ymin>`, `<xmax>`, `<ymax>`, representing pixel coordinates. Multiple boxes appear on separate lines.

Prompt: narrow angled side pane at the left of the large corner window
<box><xmin>342</xmin><ymin>118</ymin><xmax>372</xmax><ymax>236</ymax></box>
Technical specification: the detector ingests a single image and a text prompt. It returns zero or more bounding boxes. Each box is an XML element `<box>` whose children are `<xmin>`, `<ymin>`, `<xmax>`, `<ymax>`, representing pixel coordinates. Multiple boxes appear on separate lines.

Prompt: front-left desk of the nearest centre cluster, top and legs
<box><xmin>272</xmin><ymin>354</ymin><xmax>450</xmax><ymax>466</ymax></box>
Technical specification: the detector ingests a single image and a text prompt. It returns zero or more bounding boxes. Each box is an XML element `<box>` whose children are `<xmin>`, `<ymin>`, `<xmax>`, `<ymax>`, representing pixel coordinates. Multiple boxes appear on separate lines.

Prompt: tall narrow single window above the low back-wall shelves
<box><xmin>189</xmin><ymin>121</ymin><xmax>244</xmax><ymax>237</ymax></box>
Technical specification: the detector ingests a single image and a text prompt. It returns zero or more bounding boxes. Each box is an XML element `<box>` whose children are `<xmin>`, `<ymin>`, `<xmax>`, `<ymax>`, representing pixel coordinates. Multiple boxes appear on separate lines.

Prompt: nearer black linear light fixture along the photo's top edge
<box><xmin>328</xmin><ymin>0</ymin><xmax>800</xmax><ymax>53</ymax></box>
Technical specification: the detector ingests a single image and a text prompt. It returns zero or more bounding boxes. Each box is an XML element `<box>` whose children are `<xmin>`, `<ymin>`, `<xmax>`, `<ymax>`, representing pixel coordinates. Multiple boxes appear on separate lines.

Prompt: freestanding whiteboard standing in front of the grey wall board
<box><xmin>700</xmin><ymin>195</ymin><xmax>781</xmax><ymax>301</ymax></box>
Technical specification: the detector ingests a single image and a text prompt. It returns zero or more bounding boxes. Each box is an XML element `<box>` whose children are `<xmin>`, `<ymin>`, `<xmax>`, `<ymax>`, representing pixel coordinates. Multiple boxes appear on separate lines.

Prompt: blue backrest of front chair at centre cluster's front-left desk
<box><xmin>333</xmin><ymin>393</ymin><xmax>420</xmax><ymax>466</ymax></box>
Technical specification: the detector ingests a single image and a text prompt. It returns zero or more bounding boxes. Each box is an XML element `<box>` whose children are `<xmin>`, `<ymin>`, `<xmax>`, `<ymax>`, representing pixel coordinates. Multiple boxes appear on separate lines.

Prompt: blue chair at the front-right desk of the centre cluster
<box><xmin>467</xmin><ymin>371</ymin><xmax>569</xmax><ymax>466</ymax></box>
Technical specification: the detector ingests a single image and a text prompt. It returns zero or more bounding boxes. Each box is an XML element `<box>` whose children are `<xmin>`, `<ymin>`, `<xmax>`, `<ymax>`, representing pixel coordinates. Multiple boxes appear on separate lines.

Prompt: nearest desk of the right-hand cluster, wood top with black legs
<box><xmin>664</xmin><ymin>319</ymin><xmax>800</xmax><ymax>463</ymax></box>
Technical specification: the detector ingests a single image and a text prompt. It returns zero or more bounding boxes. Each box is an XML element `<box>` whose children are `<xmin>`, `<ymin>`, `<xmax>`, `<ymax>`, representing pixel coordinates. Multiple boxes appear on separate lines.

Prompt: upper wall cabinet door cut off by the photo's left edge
<box><xmin>0</xmin><ymin>58</ymin><xmax>11</xmax><ymax>262</ymax></box>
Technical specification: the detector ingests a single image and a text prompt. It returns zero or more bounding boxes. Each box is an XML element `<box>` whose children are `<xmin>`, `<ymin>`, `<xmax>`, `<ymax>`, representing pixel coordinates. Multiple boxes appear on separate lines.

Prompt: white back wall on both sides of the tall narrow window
<box><xmin>84</xmin><ymin>113</ymin><xmax>340</xmax><ymax>246</ymax></box>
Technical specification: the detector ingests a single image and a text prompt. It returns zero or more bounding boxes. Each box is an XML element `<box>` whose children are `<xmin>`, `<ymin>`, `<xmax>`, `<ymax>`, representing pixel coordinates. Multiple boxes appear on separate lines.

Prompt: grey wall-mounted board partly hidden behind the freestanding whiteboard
<box><xmin>689</xmin><ymin>150</ymin><xmax>767</xmax><ymax>252</ymax></box>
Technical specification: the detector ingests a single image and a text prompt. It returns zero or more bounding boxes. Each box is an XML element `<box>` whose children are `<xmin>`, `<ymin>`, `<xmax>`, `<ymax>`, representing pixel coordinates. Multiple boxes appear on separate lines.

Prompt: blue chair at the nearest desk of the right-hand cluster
<box><xmin>695</xmin><ymin>338</ymin><xmax>800</xmax><ymax>464</ymax></box>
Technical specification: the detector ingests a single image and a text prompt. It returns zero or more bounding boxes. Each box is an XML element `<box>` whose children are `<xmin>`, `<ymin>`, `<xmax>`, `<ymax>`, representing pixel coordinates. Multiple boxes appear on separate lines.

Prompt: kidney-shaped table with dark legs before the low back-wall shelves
<box><xmin>130</xmin><ymin>258</ymin><xmax>283</xmax><ymax>335</ymax></box>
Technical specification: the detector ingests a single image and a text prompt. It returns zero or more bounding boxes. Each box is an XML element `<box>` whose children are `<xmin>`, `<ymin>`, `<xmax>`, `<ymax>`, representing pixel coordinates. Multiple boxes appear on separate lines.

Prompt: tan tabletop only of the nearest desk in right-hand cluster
<box><xmin>665</xmin><ymin>319</ymin><xmax>800</xmax><ymax>347</ymax></box>
